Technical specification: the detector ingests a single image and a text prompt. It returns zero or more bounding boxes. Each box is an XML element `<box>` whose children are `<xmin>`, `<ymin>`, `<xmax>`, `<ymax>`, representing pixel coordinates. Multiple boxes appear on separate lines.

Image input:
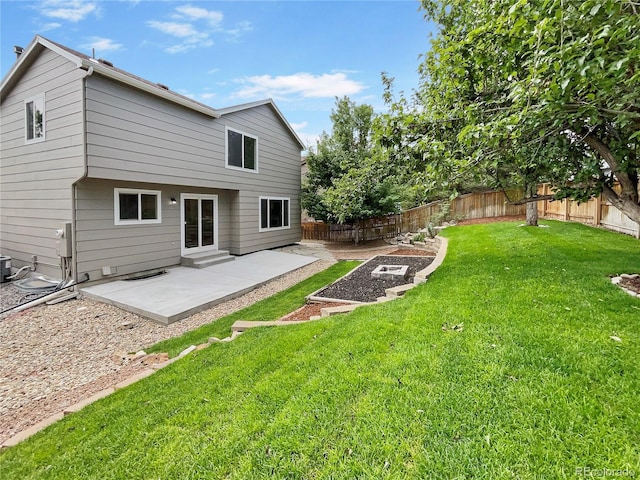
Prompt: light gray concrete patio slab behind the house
<box><xmin>81</xmin><ymin>250</ymin><xmax>318</xmax><ymax>324</ymax></box>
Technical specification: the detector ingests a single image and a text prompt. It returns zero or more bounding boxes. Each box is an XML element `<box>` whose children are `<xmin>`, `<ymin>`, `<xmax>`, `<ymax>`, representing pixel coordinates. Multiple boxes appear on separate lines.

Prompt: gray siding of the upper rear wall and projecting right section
<box><xmin>85</xmin><ymin>75</ymin><xmax>300</xmax><ymax>255</ymax></box>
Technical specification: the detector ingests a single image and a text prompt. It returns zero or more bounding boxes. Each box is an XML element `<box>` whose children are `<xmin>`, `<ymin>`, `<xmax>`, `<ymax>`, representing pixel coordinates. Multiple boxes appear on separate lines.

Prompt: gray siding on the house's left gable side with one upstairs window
<box><xmin>0</xmin><ymin>49</ymin><xmax>84</xmax><ymax>278</ymax></box>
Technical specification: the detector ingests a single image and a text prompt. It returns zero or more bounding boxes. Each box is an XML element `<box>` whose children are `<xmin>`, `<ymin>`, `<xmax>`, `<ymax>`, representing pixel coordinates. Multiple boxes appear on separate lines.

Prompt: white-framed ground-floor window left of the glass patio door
<box><xmin>113</xmin><ymin>188</ymin><xmax>162</xmax><ymax>225</ymax></box>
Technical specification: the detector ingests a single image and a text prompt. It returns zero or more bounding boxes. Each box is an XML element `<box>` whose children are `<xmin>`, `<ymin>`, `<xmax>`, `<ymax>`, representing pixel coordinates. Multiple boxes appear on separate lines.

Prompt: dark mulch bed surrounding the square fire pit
<box><xmin>316</xmin><ymin>255</ymin><xmax>433</xmax><ymax>302</ymax></box>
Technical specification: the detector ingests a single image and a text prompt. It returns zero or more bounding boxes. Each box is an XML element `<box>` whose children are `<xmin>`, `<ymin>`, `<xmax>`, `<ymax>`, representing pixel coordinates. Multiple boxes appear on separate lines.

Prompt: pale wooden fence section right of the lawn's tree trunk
<box><xmin>538</xmin><ymin>184</ymin><xmax>640</xmax><ymax>238</ymax></box>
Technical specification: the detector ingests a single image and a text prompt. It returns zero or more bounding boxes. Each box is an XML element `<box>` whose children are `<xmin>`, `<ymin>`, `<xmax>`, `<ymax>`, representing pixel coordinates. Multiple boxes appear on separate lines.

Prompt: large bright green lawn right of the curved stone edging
<box><xmin>0</xmin><ymin>222</ymin><xmax>640</xmax><ymax>479</ymax></box>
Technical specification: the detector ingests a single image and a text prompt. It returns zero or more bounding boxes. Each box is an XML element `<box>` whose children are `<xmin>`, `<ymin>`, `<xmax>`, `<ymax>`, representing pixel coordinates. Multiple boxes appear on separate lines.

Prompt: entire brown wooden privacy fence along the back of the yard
<box><xmin>302</xmin><ymin>184</ymin><xmax>640</xmax><ymax>242</ymax></box>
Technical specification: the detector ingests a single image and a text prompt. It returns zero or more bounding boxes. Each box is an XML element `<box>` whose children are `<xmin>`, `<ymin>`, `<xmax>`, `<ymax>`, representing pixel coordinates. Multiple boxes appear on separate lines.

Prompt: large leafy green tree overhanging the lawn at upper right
<box><xmin>382</xmin><ymin>0</ymin><xmax>640</xmax><ymax>223</ymax></box>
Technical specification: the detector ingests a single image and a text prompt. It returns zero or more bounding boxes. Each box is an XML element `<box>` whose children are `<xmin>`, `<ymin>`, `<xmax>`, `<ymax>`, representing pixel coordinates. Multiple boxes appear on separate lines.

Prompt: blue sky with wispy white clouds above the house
<box><xmin>0</xmin><ymin>0</ymin><xmax>432</xmax><ymax>149</ymax></box>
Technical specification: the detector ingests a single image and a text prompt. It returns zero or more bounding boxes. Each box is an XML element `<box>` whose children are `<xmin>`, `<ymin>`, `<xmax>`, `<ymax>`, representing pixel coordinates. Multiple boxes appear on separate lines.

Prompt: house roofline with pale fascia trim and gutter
<box><xmin>0</xmin><ymin>35</ymin><xmax>306</xmax><ymax>149</ymax></box>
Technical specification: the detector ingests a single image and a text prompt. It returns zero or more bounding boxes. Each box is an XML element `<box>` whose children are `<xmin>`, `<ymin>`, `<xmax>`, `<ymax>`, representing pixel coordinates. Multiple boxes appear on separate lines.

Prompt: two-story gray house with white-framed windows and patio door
<box><xmin>0</xmin><ymin>36</ymin><xmax>304</xmax><ymax>281</ymax></box>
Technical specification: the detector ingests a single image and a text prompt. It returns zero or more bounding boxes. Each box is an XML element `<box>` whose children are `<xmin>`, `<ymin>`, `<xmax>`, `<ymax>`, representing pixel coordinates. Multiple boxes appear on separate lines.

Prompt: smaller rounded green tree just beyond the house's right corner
<box><xmin>302</xmin><ymin>97</ymin><xmax>398</xmax><ymax>243</ymax></box>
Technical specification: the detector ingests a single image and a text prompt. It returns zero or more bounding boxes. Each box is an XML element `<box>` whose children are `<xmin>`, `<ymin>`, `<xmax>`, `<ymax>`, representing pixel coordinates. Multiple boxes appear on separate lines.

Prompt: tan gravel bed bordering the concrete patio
<box><xmin>0</xmin><ymin>260</ymin><xmax>333</xmax><ymax>442</ymax></box>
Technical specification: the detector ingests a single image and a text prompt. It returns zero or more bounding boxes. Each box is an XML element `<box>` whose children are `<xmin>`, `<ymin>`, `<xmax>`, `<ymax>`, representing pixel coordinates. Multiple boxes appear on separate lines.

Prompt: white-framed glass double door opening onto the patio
<box><xmin>180</xmin><ymin>193</ymin><xmax>218</xmax><ymax>255</ymax></box>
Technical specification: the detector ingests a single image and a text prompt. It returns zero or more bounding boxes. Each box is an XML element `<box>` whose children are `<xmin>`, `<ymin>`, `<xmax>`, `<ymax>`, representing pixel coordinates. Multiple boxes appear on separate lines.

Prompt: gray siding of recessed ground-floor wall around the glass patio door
<box><xmin>76</xmin><ymin>179</ymin><xmax>235</xmax><ymax>282</ymax></box>
